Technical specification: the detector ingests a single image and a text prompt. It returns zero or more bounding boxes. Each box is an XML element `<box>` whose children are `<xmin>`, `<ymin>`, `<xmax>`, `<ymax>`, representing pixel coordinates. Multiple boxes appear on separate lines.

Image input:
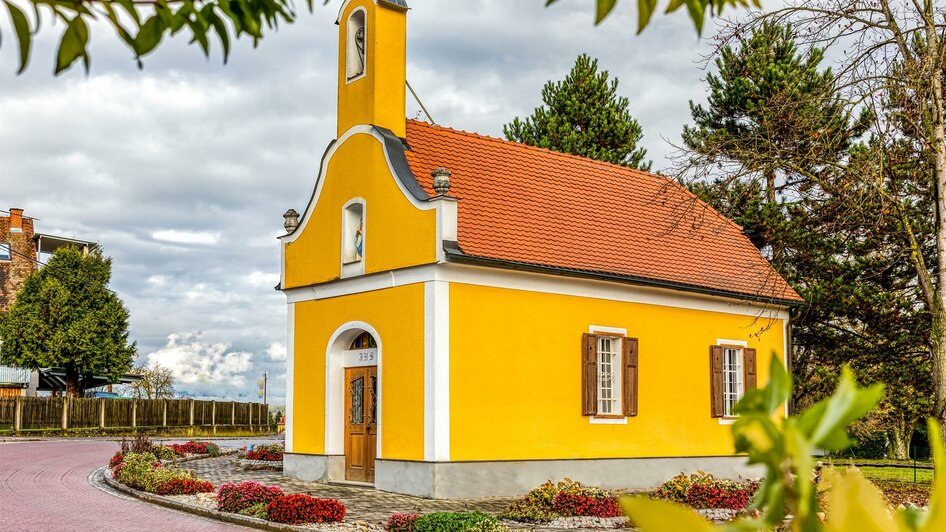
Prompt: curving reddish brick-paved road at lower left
<box><xmin>0</xmin><ymin>440</ymin><xmax>248</xmax><ymax>532</ymax></box>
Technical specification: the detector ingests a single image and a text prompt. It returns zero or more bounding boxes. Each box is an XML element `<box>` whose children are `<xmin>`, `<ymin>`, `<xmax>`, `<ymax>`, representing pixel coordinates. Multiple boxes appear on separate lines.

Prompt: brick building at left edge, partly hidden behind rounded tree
<box><xmin>0</xmin><ymin>209</ymin><xmax>97</xmax><ymax>396</ymax></box>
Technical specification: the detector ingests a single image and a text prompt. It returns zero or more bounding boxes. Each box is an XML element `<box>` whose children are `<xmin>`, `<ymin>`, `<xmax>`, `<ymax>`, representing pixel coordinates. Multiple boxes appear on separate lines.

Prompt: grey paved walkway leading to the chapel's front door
<box><xmin>182</xmin><ymin>455</ymin><xmax>513</xmax><ymax>525</ymax></box>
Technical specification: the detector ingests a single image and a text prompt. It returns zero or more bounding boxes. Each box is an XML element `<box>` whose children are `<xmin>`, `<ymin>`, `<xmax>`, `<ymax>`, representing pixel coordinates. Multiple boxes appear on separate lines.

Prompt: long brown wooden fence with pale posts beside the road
<box><xmin>0</xmin><ymin>397</ymin><xmax>269</xmax><ymax>431</ymax></box>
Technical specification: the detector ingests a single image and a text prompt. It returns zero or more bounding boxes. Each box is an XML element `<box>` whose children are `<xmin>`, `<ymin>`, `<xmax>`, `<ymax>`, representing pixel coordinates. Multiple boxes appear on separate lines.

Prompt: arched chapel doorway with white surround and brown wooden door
<box><xmin>325</xmin><ymin>322</ymin><xmax>381</xmax><ymax>483</ymax></box>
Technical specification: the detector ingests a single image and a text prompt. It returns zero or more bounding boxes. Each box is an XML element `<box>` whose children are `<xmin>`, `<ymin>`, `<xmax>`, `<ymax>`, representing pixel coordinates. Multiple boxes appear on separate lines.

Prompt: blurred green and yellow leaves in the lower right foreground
<box><xmin>621</xmin><ymin>354</ymin><xmax>946</xmax><ymax>532</ymax></box>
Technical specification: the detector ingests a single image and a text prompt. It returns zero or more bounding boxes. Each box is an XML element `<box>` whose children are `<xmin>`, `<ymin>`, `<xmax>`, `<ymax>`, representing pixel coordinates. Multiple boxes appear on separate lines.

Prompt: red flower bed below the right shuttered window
<box><xmin>653</xmin><ymin>472</ymin><xmax>759</xmax><ymax>511</ymax></box>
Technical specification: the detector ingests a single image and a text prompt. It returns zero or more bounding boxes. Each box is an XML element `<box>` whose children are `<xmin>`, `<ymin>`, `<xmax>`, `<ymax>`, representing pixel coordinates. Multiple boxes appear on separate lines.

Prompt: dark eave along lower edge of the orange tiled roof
<box><xmin>443</xmin><ymin>241</ymin><xmax>804</xmax><ymax>308</ymax></box>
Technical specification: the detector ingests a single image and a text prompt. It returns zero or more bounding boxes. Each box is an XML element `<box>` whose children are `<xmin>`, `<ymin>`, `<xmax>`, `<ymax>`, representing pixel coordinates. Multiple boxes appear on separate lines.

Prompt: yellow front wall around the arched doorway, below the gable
<box><xmin>292</xmin><ymin>284</ymin><xmax>424</xmax><ymax>460</ymax></box>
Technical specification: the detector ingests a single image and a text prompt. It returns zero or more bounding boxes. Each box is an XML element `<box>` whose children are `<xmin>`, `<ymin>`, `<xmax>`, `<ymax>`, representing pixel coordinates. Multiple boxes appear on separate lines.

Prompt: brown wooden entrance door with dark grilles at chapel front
<box><xmin>345</xmin><ymin>366</ymin><xmax>378</xmax><ymax>482</ymax></box>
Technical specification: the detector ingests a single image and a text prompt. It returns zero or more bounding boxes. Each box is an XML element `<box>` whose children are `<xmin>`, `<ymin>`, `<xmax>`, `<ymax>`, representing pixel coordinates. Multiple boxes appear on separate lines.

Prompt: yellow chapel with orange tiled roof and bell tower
<box><xmin>279</xmin><ymin>0</ymin><xmax>801</xmax><ymax>497</ymax></box>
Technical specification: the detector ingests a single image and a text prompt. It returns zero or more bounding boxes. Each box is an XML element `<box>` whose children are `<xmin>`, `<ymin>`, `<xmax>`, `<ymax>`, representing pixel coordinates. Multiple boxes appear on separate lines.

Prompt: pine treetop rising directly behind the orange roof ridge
<box><xmin>503</xmin><ymin>54</ymin><xmax>651</xmax><ymax>170</ymax></box>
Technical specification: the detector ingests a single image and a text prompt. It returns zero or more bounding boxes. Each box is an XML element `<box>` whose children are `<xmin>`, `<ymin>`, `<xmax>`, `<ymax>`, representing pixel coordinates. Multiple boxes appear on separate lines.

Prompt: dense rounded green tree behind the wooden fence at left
<box><xmin>0</xmin><ymin>247</ymin><xmax>137</xmax><ymax>397</ymax></box>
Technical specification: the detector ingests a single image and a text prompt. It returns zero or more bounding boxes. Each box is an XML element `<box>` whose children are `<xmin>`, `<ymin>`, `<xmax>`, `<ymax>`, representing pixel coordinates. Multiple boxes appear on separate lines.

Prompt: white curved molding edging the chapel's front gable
<box><xmin>279</xmin><ymin>124</ymin><xmax>457</xmax><ymax>288</ymax></box>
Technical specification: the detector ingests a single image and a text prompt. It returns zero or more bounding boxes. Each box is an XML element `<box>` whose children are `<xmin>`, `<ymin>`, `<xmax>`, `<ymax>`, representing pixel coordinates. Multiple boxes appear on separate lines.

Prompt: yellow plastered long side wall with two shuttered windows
<box><xmin>450</xmin><ymin>284</ymin><xmax>784</xmax><ymax>460</ymax></box>
